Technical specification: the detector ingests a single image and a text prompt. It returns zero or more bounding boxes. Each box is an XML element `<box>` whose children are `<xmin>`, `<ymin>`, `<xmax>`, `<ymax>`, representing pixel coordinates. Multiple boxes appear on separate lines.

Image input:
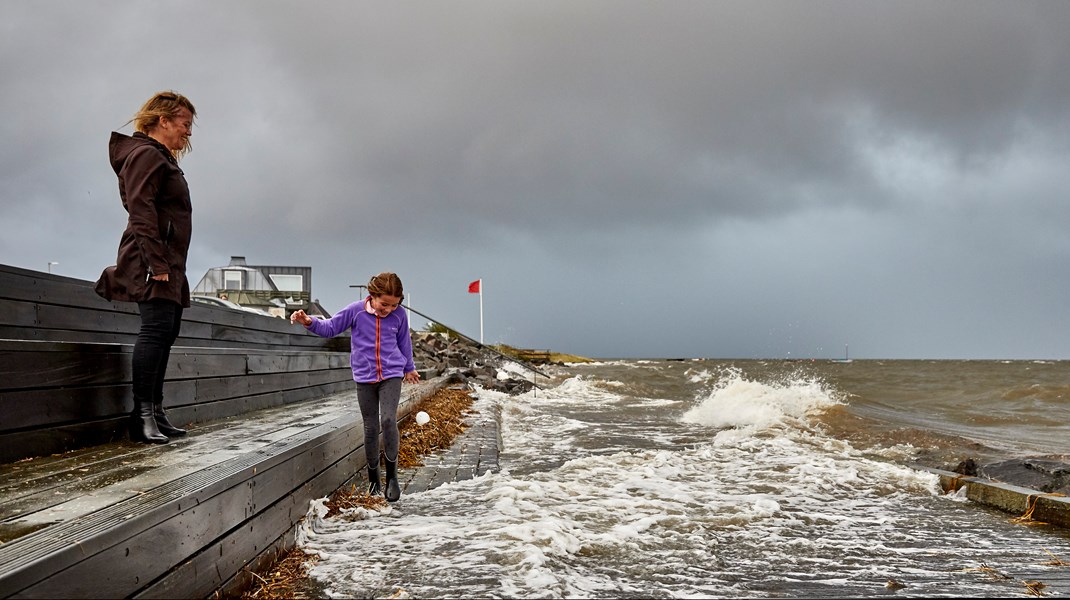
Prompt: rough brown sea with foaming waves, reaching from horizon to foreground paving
<box><xmin>301</xmin><ymin>360</ymin><xmax>1070</xmax><ymax>598</ymax></box>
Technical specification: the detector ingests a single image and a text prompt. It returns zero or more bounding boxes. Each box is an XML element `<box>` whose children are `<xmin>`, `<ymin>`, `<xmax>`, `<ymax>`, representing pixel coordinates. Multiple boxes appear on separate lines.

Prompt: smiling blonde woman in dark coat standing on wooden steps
<box><xmin>96</xmin><ymin>92</ymin><xmax>197</xmax><ymax>444</ymax></box>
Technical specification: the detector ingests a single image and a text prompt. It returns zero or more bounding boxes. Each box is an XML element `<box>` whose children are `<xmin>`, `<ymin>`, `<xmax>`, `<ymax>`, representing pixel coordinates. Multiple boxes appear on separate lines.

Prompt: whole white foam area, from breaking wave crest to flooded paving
<box><xmin>303</xmin><ymin>357</ymin><xmax>1061</xmax><ymax>598</ymax></box>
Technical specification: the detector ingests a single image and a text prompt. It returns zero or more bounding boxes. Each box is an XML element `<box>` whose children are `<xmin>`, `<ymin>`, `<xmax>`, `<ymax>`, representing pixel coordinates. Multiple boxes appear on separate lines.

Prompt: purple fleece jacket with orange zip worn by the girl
<box><xmin>307</xmin><ymin>296</ymin><xmax>416</xmax><ymax>383</ymax></box>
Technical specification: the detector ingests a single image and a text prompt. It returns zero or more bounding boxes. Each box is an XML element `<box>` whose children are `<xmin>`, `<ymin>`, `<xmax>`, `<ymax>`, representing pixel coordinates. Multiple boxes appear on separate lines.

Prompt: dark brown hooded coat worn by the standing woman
<box><xmin>96</xmin><ymin>132</ymin><xmax>193</xmax><ymax>307</ymax></box>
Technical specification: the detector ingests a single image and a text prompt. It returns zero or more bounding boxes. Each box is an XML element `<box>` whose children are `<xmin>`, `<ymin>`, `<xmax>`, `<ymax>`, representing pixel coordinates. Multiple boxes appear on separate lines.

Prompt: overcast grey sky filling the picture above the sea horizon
<box><xmin>0</xmin><ymin>0</ymin><xmax>1070</xmax><ymax>359</ymax></box>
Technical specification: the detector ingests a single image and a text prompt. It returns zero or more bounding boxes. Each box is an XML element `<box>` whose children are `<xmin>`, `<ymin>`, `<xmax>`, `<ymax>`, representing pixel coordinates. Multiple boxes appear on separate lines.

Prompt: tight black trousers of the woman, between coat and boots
<box><xmin>132</xmin><ymin>301</ymin><xmax>182</xmax><ymax>403</ymax></box>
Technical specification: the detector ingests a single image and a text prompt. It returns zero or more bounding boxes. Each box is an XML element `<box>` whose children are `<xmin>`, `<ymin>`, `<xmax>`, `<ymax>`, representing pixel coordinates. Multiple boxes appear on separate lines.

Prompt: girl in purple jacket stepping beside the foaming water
<box><xmin>290</xmin><ymin>273</ymin><xmax>419</xmax><ymax>502</ymax></box>
